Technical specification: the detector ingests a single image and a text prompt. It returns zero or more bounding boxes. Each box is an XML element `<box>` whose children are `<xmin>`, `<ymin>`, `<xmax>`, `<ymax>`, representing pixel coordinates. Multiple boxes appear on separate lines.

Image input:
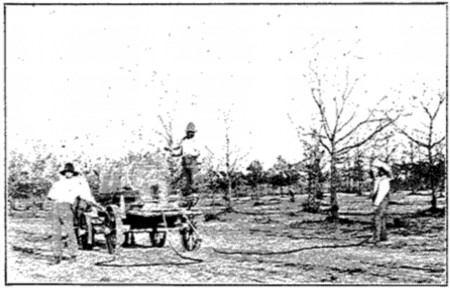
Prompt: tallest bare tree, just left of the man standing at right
<box><xmin>304</xmin><ymin>62</ymin><xmax>400</xmax><ymax>220</ymax></box>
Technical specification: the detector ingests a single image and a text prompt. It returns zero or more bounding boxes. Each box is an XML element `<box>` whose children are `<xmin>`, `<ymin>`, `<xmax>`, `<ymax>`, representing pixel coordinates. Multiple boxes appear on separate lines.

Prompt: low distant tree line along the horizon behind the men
<box><xmin>8</xmin><ymin>146</ymin><xmax>446</xmax><ymax>211</ymax></box>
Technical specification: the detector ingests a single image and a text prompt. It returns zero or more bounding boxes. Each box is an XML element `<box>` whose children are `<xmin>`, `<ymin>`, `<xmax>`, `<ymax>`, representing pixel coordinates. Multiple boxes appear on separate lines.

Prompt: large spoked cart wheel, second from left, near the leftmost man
<box><xmin>105</xmin><ymin>205</ymin><xmax>124</xmax><ymax>254</ymax></box>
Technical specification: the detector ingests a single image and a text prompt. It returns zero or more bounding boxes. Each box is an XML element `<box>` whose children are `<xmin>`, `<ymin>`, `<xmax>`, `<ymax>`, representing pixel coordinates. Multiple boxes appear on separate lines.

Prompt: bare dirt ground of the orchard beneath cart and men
<box><xmin>7</xmin><ymin>192</ymin><xmax>447</xmax><ymax>285</ymax></box>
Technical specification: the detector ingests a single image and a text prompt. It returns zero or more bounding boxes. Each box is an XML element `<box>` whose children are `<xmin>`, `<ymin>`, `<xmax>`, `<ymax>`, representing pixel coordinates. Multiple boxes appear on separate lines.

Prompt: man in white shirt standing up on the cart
<box><xmin>166</xmin><ymin>122</ymin><xmax>200</xmax><ymax>196</ymax></box>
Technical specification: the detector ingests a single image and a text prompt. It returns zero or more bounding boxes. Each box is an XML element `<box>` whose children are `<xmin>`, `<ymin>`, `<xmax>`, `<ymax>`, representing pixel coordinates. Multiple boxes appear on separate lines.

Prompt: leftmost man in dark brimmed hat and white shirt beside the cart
<box><xmin>47</xmin><ymin>163</ymin><xmax>99</xmax><ymax>264</ymax></box>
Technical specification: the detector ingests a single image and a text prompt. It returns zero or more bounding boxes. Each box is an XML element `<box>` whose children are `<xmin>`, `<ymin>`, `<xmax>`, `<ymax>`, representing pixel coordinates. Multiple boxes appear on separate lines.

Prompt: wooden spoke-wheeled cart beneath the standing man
<box><xmin>75</xmin><ymin>191</ymin><xmax>202</xmax><ymax>254</ymax></box>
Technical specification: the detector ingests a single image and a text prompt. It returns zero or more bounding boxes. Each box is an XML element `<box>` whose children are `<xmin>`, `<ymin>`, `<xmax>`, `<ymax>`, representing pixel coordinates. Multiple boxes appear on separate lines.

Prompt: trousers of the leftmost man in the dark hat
<box><xmin>52</xmin><ymin>202</ymin><xmax>78</xmax><ymax>257</ymax></box>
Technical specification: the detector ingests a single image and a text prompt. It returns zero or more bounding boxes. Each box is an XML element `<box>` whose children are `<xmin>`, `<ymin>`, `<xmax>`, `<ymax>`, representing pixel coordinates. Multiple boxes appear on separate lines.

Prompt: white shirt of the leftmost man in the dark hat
<box><xmin>47</xmin><ymin>176</ymin><xmax>96</xmax><ymax>204</ymax></box>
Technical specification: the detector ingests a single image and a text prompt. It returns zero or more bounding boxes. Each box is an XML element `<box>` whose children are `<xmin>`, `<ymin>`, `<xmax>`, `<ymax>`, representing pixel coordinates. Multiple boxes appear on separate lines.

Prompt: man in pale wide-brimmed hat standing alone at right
<box><xmin>371</xmin><ymin>160</ymin><xmax>392</xmax><ymax>243</ymax></box>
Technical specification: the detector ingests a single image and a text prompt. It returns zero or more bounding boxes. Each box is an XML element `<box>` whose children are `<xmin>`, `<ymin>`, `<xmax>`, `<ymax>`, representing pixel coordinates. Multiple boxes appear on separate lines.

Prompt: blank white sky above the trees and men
<box><xmin>6</xmin><ymin>5</ymin><xmax>446</xmax><ymax>167</ymax></box>
